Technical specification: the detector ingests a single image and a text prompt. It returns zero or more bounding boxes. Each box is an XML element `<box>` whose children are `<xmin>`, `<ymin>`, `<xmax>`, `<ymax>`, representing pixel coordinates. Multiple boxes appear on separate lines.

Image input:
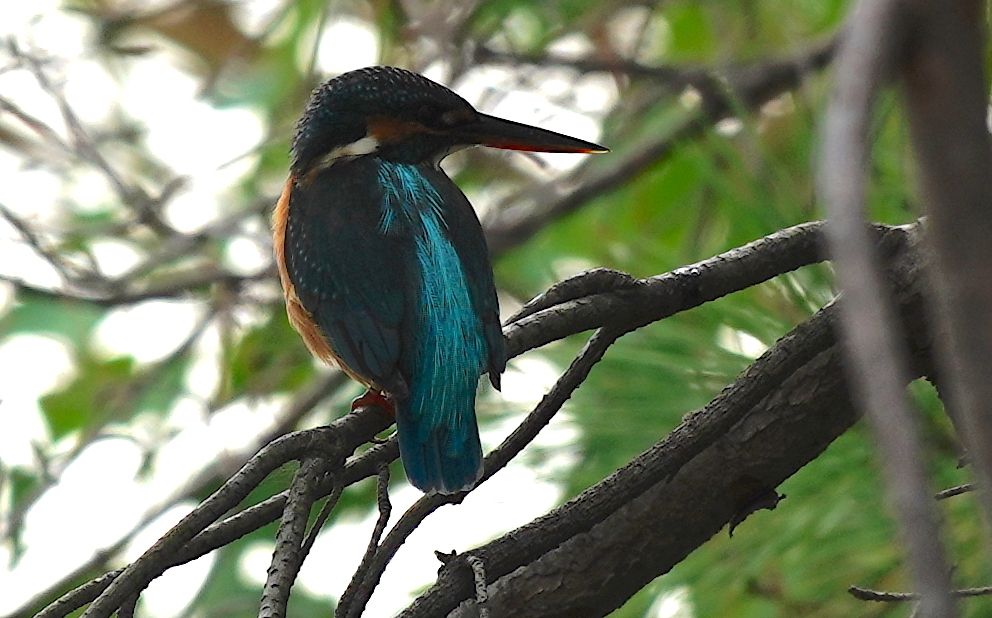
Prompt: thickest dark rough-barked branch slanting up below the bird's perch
<box><xmin>400</xmin><ymin>225</ymin><xmax>931</xmax><ymax>618</ymax></box>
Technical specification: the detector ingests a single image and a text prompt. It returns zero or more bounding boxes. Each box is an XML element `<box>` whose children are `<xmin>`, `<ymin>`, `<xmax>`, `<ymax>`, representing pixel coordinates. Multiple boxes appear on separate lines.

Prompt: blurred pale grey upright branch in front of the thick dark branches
<box><xmin>818</xmin><ymin>0</ymin><xmax>956</xmax><ymax>618</ymax></box>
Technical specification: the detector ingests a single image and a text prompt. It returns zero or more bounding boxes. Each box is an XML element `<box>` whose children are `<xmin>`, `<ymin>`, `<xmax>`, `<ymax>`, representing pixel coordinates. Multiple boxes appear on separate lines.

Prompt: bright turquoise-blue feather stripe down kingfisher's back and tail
<box><xmin>378</xmin><ymin>162</ymin><xmax>488</xmax><ymax>493</ymax></box>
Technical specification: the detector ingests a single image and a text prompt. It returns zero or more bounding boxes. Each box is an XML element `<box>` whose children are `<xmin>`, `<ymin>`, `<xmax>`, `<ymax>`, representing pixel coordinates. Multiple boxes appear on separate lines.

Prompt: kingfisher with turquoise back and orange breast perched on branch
<box><xmin>273</xmin><ymin>66</ymin><xmax>606</xmax><ymax>494</ymax></box>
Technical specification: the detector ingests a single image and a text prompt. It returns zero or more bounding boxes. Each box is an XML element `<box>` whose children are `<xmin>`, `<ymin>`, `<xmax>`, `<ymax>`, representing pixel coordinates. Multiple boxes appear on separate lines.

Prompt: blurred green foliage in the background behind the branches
<box><xmin>0</xmin><ymin>0</ymin><xmax>992</xmax><ymax>618</ymax></box>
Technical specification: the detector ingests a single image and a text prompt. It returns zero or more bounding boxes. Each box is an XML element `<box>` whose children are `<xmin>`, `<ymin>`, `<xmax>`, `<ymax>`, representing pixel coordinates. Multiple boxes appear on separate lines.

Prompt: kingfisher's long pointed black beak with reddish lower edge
<box><xmin>457</xmin><ymin>114</ymin><xmax>609</xmax><ymax>152</ymax></box>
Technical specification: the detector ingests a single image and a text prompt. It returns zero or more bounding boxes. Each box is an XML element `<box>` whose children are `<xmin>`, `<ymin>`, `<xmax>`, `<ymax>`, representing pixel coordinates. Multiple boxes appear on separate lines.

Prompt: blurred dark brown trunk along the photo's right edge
<box><xmin>901</xmin><ymin>0</ymin><xmax>992</xmax><ymax>564</ymax></box>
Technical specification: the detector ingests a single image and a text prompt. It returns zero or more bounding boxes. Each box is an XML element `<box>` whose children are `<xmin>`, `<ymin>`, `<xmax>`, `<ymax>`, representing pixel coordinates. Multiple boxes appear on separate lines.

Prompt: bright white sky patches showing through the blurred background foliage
<box><xmin>0</xmin><ymin>0</ymin><xmax>728</xmax><ymax>618</ymax></box>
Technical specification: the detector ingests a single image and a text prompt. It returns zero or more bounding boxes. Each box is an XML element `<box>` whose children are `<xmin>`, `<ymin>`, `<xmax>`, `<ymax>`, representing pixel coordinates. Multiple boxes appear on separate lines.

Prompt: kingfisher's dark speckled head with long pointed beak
<box><xmin>293</xmin><ymin>66</ymin><xmax>606</xmax><ymax>177</ymax></box>
